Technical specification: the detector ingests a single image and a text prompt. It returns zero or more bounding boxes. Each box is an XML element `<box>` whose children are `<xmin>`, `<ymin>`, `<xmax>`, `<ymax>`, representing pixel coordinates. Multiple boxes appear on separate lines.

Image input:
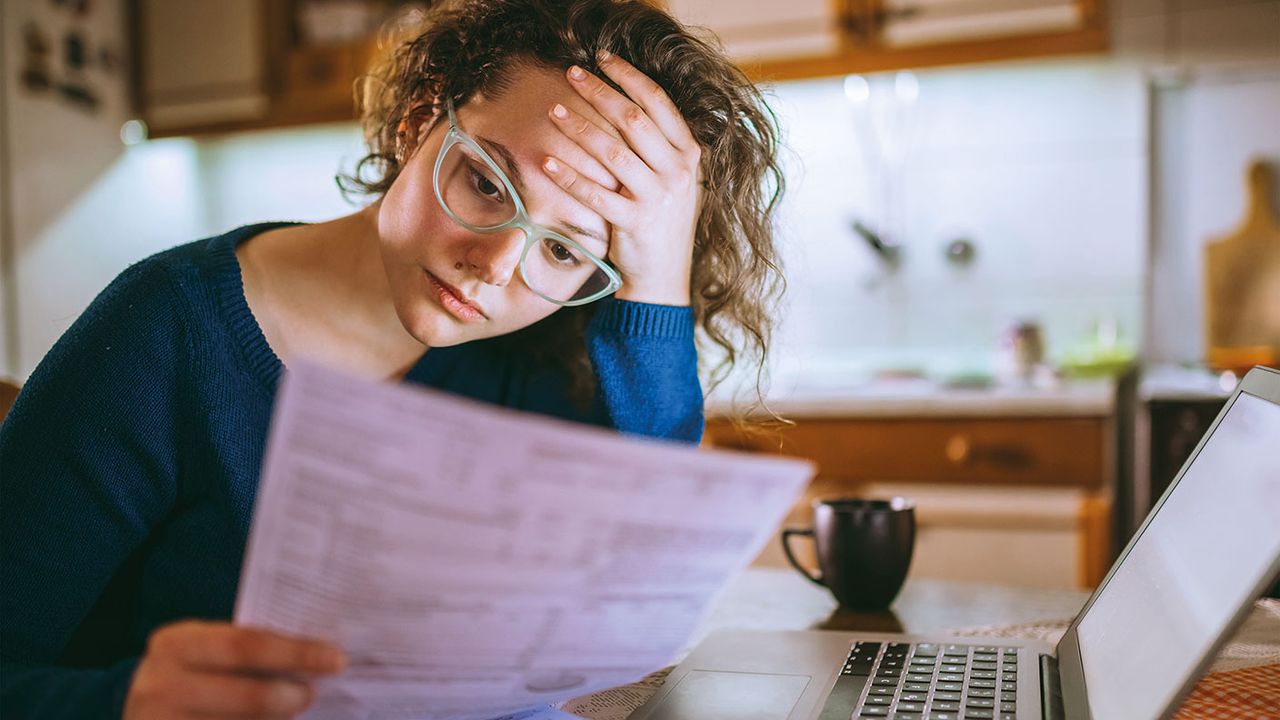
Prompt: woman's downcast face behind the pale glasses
<box><xmin>378</xmin><ymin>60</ymin><xmax>618</xmax><ymax>347</ymax></box>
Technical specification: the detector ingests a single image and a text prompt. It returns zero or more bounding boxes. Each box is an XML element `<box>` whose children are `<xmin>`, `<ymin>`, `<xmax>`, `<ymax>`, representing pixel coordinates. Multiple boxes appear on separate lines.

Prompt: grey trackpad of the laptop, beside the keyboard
<box><xmin>650</xmin><ymin>670</ymin><xmax>809</xmax><ymax>720</ymax></box>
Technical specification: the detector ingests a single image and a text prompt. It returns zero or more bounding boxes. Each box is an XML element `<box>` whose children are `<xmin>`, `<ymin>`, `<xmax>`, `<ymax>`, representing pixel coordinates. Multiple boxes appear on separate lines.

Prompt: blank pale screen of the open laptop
<box><xmin>1076</xmin><ymin>392</ymin><xmax>1280</xmax><ymax>719</ymax></box>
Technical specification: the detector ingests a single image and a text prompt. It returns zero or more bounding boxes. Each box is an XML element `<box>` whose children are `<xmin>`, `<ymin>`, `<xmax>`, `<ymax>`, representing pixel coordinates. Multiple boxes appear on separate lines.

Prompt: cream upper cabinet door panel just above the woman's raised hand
<box><xmin>667</xmin><ymin>0</ymin><xmax>841</xmax><ymax>60</ymax></box>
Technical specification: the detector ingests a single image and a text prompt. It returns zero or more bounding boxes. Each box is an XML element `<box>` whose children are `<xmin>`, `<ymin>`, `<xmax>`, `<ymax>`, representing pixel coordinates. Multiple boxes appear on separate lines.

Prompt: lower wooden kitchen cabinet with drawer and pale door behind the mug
<box><xmin>705</xmin><ymin>416</ymin><xmax>1115</xmax><ymax>587</ymax></box>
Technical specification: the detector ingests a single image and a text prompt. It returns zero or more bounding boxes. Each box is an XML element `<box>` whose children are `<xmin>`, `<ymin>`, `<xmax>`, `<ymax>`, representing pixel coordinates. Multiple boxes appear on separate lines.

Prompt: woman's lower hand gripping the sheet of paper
<box><xmin>124</xmin><ymin>620</ymin><xmax>344</xmax><ymax>720</ymax></box>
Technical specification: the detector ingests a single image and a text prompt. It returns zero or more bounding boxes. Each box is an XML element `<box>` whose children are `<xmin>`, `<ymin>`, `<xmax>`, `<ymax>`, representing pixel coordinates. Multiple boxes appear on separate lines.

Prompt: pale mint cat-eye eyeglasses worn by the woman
<box><xmin>433</xmin><ymin>100</ymin><xmax>622</xmax><ymax>305</ymax></box>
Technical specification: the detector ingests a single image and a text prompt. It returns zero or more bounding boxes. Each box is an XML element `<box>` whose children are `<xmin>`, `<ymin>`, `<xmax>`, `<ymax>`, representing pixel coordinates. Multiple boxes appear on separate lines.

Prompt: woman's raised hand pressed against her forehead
<box><xmin>543</xmin><ymin>53</ymin><xmax>701</xmax><ymax>305</ymax></box>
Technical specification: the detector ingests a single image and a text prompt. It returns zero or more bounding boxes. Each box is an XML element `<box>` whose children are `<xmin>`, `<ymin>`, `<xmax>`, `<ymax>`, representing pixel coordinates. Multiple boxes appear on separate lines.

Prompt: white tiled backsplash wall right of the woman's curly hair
<box><xmin>747</xmin><ymin>60</ymin><xmax>1148</xmax><ymax>386</ymax></box>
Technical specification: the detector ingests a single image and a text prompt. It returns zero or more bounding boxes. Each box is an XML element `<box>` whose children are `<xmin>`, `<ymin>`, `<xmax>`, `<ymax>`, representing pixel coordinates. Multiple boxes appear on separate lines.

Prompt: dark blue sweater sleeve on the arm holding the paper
<box><xmin>0</xmin><ymin>260</ymin><xmax>189</xmax><ymax>719</ymax></box>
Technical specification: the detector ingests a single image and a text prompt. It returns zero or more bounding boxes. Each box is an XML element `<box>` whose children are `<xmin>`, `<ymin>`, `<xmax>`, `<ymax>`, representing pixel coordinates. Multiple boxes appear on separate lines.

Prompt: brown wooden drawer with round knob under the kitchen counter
<box><xmin>707</xmin><ymin>418</ymin><xmax>1108</xmax><ymax>488</ymax></box>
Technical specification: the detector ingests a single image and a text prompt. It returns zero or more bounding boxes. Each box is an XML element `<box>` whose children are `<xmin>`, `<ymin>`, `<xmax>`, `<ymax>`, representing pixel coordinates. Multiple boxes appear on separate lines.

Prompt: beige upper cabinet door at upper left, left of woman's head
<box><xmin>137</xmin><ymin>0</ymin><xmax>269</xmax><ymax>131</ymax></box>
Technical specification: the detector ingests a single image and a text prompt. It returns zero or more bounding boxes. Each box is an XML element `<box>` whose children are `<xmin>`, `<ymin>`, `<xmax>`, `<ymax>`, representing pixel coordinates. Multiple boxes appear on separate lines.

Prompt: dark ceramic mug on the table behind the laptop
<box><xmin>782</xmin><ymin>497</ymin><xmax>915</xmax><ymax>610</ymax></box>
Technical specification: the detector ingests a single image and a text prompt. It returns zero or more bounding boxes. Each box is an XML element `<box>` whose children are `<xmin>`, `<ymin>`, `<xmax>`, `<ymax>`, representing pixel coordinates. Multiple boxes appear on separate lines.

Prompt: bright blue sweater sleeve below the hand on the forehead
<box><xmin>586</xmin><ymin>300</ymin><xmax>703</xmax><ymax>443</ymax></box>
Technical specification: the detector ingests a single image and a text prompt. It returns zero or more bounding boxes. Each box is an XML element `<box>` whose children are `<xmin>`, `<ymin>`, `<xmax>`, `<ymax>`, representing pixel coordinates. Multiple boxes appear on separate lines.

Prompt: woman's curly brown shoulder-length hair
<box><xmin>339</xmin><ymin>0</ymin><xmax>785</xmax><ymax>409</ymax></box>
